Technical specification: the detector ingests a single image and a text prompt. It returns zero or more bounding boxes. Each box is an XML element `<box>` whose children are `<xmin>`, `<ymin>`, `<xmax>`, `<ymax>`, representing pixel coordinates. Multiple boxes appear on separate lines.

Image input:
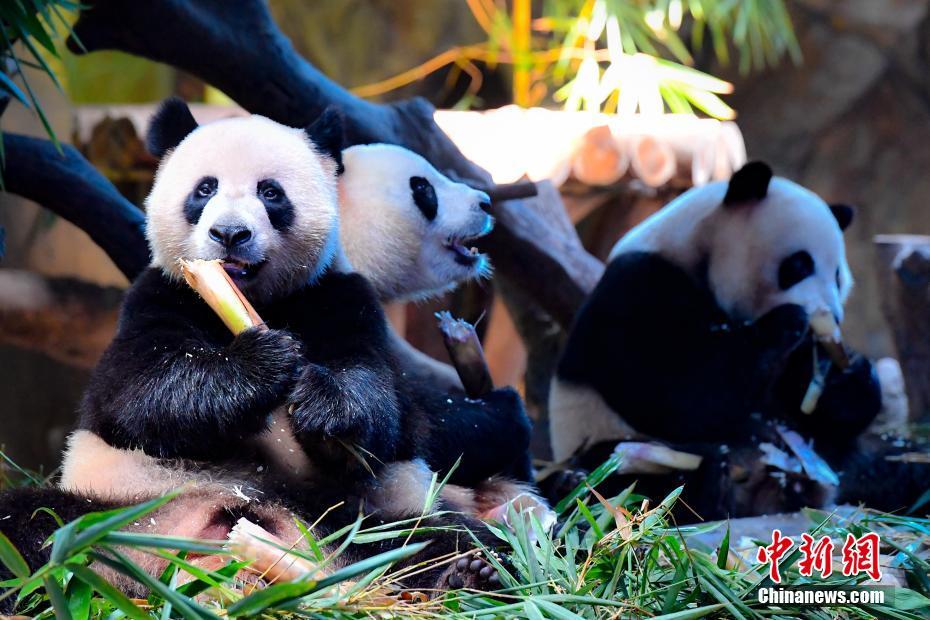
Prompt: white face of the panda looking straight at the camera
<box><xmin>146</xmin><ymin>104</ymin><xmax>338</xmax><ymax>301</ymax></box>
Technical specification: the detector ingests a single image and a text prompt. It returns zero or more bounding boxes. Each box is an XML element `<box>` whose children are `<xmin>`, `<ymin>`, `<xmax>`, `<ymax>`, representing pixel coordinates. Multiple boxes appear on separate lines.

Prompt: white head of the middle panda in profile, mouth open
<box><xmin>339</xmin><ymin>144</ymin><xmax>494</xmax><ymax>300</ymax></box>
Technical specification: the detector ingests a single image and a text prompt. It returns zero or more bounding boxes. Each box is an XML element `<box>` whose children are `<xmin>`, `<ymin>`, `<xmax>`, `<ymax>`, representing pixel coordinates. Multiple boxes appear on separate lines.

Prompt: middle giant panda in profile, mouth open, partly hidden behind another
<box><xmin>339</xmin><ymin>144</ymin><xmax>533</xmax><ymax>486</ymax></box>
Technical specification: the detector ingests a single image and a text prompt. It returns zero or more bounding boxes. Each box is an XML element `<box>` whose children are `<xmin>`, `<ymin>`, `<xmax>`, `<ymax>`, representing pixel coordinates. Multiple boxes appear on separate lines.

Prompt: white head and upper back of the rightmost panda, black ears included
<box><xmin>611</xmin><ymin>162</ymin><xmax>853</xmax><ymax>323</ymax></box>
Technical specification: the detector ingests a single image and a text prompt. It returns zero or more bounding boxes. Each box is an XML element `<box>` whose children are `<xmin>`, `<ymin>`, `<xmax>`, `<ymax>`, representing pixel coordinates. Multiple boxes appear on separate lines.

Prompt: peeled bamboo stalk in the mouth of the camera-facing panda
<box><xmin>181</xmin><ymin>259</ymin><xmax>265</xmax><ymax>335</ymax></box>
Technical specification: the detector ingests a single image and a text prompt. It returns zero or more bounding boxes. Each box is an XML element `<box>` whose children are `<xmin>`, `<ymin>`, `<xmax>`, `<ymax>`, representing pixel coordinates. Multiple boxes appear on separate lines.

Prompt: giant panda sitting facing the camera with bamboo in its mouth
<box><xmin>4</xmin><ymin>100</ymin><xmax>507</xmax><ymax>608</ymax></box>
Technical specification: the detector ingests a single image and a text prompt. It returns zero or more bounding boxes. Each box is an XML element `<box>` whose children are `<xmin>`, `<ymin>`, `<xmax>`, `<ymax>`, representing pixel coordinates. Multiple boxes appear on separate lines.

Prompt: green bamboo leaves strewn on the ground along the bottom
<box><xmin>0</xmin><ymin>456</ymin><xmax>930</xmax><ymax>620</ymax></box>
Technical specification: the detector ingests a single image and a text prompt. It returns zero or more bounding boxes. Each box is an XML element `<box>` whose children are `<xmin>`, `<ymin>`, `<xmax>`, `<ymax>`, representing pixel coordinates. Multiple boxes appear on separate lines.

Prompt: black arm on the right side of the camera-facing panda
<box><xmin>270</xmin><ymin>273</ymin><xmax>401</xmax><ymax>468</ymax></box>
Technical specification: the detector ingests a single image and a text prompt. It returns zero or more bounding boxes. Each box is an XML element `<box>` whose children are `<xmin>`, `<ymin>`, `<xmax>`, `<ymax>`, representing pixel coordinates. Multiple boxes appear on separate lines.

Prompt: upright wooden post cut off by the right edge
<box><xmin>875</xmin><ymin>235</ymin><xmax>930</xmax><ymax>420</ymax></box>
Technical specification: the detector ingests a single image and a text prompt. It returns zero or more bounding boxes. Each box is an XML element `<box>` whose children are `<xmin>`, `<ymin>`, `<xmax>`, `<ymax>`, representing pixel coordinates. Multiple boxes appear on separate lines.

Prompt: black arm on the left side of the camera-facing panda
<box><xmin>81</xmin><ymin>269</ymin><xmax>300</xmax><ymax>458</ymax></box>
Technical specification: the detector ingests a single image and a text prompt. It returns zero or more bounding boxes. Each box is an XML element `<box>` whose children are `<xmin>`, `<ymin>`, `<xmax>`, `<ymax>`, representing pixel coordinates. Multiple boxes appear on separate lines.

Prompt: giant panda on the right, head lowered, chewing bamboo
<box><xmin>549</xmin><ymin>162</ymin><xmax>921</xmax><ymax>517</ymax></box>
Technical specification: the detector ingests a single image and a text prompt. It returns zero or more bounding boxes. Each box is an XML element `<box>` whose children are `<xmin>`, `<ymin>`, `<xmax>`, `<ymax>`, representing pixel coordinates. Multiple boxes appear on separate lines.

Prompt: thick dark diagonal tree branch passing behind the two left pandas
<box><xmin>69</xmin><ymin>0</ymin><xmax>603</xmax><ymax>326</ymax></box>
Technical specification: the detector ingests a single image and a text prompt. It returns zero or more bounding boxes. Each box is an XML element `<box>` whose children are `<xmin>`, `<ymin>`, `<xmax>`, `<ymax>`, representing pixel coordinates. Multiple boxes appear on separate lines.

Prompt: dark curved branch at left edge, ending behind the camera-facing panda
<box><xmin>3</xmin><ymin>133</ymin><xmax>149</xmax><ymax>280</ymax></box>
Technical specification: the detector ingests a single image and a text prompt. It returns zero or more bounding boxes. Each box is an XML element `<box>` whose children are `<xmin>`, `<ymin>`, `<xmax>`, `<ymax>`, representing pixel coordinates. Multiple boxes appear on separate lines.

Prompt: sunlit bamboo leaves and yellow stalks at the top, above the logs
<box><xmin>355</xmin><ymin>0</ymin><xmax>801</xmax><ymax>119</ymax></box>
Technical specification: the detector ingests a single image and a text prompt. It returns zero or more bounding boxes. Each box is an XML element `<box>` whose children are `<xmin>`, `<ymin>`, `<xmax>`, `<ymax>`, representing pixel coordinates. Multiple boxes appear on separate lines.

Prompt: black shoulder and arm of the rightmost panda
<box><xmin>558</xmin><ymin>252</ymin><xmax>807</xmax><ymax>442</ymax></box>
